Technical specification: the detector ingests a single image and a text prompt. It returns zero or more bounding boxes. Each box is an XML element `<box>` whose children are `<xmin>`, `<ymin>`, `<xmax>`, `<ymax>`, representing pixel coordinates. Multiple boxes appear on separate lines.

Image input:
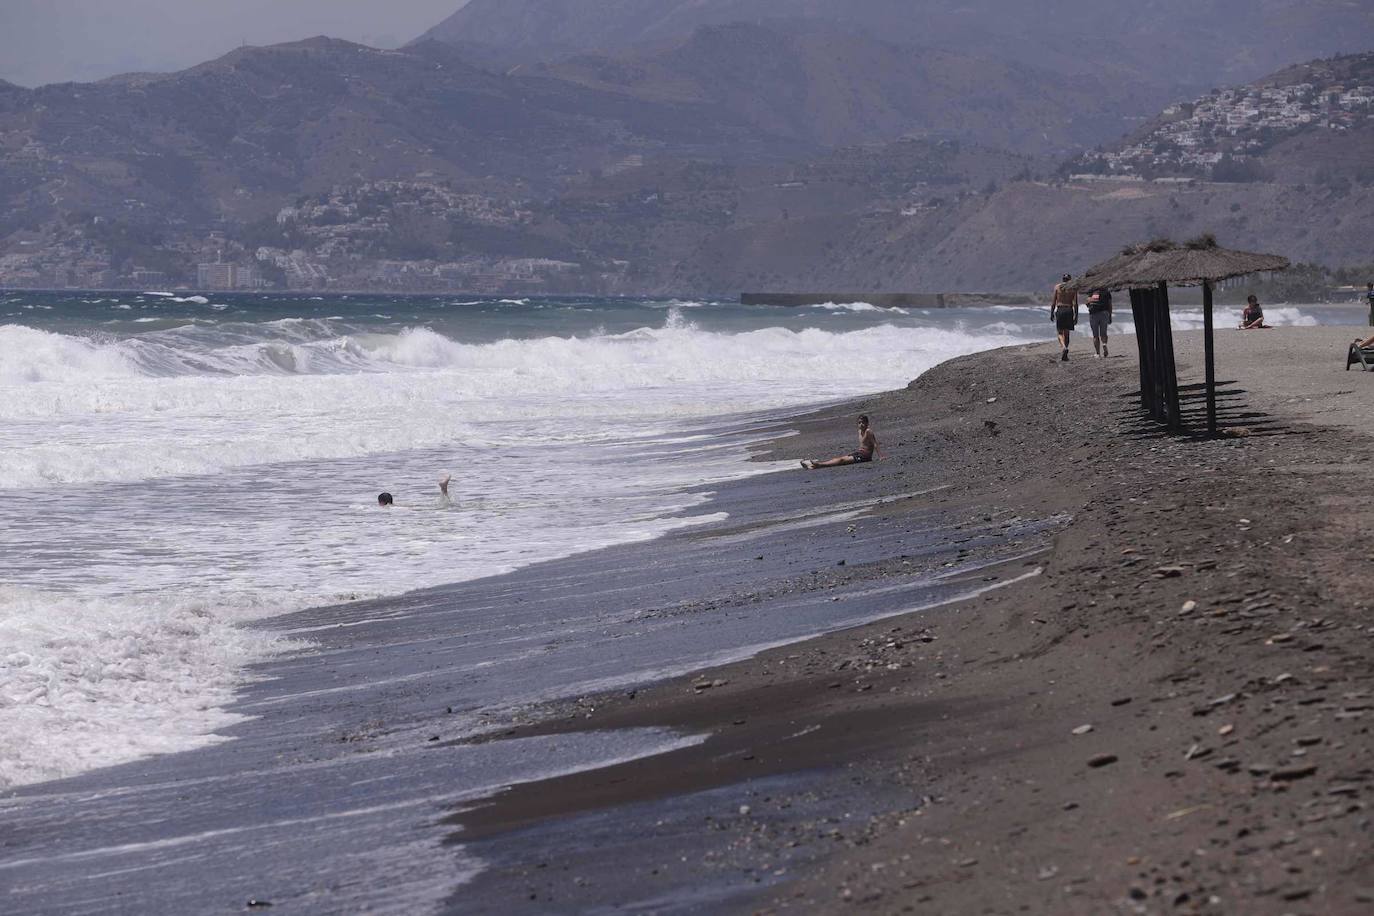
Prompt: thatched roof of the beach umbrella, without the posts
<box><xmin>1074</xmin><ymin>233</ymin><xmax>1289</xmax><ymax>290</ymax></box>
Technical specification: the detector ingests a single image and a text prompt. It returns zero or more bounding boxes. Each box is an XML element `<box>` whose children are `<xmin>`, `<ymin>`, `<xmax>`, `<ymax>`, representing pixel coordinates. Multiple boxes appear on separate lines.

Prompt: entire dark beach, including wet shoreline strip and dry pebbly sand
<box><xmin>0</xmin><ymin>318</ymin><xmax>1374</xmax><ymax>913</ymax></box>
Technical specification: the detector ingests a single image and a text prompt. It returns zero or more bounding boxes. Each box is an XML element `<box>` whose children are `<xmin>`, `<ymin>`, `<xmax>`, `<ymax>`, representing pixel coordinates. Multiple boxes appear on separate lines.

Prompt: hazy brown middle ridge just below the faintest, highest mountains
<box><xmin>535</xmin><ymin>19</ymin><xmax>1168</xmax><ymax>154</ymax></box>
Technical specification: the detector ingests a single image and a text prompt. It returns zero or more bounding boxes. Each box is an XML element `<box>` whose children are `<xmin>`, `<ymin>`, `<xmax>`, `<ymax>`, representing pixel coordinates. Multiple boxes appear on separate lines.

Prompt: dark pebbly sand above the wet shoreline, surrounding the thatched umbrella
<box><xmin>452</xmin><ymin>328</ymin><xmax>1374</xmax><ymax>913</ymax></box>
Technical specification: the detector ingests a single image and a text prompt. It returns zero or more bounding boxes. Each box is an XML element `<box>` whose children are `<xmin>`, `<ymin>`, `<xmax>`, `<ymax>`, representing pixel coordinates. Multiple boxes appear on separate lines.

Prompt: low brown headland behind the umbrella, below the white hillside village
<box><xmin>661</xmin><ymin>181</ymin><xmax>1374</xmax><ymax>293</ymax></box>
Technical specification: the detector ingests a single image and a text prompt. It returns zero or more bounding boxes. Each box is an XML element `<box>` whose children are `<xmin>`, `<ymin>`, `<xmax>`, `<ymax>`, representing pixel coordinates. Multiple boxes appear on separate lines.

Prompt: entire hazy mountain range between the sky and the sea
<box><xmin>0</xmin><ymin>0</ymin><xmax>1374</xmax><ymax>294</ymax></box>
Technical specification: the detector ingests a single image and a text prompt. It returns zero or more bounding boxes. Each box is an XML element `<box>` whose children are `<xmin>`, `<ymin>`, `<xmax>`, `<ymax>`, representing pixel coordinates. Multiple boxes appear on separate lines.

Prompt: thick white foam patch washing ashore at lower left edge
<box><xmin>0</xmin><ymin>585</ymin><xmax>280</xmax><ymax>787</ymax></box>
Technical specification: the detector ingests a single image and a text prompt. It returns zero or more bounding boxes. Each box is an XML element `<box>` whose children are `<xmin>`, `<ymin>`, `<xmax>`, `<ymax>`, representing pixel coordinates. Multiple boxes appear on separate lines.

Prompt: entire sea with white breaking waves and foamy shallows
<box><xmin>0</xmin><ymin>293</ymin><xmax>1341</xmax><ymax>787</ymax></box>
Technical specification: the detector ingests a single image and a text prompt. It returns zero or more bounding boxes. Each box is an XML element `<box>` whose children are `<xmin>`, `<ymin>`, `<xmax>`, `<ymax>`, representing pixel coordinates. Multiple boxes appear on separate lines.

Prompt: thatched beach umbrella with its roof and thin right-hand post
<box><xmin>1074</xmin><ymin>233</ymin><xmax>1289</xmax><ymax>435</ymax></box>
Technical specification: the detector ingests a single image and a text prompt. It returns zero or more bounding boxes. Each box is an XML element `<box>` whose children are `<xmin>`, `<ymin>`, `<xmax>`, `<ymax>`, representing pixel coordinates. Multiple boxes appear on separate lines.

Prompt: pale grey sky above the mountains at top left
<box><xmin>0</xmin><ymin>0</ymin><xmax>466</xmax><ymax>87</ymax></box>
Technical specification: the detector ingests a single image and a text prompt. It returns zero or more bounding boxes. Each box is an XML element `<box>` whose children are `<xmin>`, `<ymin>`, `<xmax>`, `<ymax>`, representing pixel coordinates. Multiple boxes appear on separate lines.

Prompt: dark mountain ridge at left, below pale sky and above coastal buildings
<box><xmin>0</xmin><ymin>38</ymin><xmax>794</xmax><ymax>233</ymax></box>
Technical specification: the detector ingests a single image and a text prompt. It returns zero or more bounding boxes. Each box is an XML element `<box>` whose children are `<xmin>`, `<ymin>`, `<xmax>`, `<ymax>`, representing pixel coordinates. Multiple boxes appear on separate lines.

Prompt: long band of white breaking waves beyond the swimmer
<box><xmin>0</xmin><ymin>318</ymin><xmax>1022</xmax><ymax>489</ymax></box>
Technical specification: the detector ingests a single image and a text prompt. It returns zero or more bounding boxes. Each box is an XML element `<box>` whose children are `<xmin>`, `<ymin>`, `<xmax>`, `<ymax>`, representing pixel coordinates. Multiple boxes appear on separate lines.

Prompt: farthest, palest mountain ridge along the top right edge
<box><xmin>426</xmin><ymin>0</ymin><xmax>1374</xmax><ymax>88</ymax></box>
